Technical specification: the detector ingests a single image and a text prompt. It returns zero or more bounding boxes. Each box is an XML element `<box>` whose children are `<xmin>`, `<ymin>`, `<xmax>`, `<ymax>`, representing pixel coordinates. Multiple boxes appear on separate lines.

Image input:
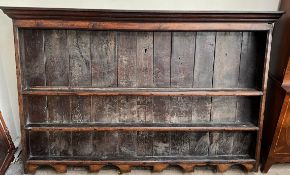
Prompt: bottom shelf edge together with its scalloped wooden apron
<box><xmin>25</xmin><ymin>156</ymin><xmax>256</xmax><ymax>173</ymax></box>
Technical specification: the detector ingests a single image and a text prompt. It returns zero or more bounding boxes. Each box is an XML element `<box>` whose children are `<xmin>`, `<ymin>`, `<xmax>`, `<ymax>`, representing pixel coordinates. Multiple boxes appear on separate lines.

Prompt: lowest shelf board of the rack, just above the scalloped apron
<box><xmin>28</xmin><ymin>155</ymin><xmax>255</xmax><ymax>164</ymax></box>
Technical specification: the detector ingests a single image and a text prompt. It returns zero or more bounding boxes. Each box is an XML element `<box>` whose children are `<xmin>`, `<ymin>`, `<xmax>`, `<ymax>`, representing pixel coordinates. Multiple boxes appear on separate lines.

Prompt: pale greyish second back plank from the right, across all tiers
<box><xmin>209</xmin><ymin>32</ymin><xmax>242</xmax><ymax>155</ymax></box>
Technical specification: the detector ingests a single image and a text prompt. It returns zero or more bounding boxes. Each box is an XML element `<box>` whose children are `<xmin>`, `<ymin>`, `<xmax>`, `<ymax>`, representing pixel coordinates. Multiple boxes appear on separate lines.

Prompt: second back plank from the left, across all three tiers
<box><xmin>44</xmin><ymin>30</ymin><xmax>71</xmax><ymax>156</ymax></box>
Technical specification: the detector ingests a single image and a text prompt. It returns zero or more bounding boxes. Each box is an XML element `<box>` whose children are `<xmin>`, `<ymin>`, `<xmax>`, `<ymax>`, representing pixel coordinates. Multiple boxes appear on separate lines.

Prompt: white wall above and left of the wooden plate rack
<box><xmin>0</xmin><ymin>0</ymin><xmax>279</xmax><ymax>144</ymax></box>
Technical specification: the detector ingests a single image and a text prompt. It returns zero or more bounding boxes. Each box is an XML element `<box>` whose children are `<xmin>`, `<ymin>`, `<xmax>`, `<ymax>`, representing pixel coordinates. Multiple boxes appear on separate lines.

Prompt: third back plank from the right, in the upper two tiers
<box><xmin>192</xmin><ymin>32</ymin><xmax>216</xmax><ymax>122</ymax></box>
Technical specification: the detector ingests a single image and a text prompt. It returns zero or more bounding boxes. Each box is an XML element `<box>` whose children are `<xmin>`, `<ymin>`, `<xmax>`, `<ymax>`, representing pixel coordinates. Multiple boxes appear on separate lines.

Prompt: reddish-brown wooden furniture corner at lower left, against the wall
<box><xmin>0</xmin><ymin>111</ymin><xmax>15</xmax><ymax>175</ymax></box>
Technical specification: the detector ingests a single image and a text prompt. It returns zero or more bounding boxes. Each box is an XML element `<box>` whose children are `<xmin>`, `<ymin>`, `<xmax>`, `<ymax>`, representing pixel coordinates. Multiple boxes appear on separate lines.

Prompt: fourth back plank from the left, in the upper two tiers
<box><xmin>91</xmin><ymin>31</ymin><xmax>119</xmax><ymax>122</ymax></box>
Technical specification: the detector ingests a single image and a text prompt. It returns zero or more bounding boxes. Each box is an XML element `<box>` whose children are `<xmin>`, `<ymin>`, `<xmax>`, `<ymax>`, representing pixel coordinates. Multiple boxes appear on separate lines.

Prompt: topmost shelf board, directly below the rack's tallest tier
<box><xmin>22</xmin><ymin>87</ymin><xmax>263</xmax><ymax>96</ymax></box>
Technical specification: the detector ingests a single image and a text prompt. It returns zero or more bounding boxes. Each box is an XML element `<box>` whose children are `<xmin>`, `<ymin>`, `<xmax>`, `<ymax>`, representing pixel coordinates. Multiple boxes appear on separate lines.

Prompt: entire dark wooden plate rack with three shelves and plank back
<box><xmin>4</xmin><ymin>8</ymin><xmax>281</xmax><ymax>172</ymax></box>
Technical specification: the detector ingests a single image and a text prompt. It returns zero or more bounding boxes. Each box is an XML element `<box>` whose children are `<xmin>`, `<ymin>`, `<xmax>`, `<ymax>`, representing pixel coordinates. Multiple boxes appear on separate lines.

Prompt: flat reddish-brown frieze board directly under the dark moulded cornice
<box><xmin>14</xmin><ymin>19</ymin><xmax>273</xmax><ymax>32</ymax></box>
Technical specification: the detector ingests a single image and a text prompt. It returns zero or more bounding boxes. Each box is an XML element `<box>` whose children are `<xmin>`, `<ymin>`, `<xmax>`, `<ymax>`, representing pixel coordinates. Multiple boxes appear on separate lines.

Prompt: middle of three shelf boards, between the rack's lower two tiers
<box><xmin>25</xmin><ymin>123</ymin><xmax>259</xmax><ymax>132</ymax></box>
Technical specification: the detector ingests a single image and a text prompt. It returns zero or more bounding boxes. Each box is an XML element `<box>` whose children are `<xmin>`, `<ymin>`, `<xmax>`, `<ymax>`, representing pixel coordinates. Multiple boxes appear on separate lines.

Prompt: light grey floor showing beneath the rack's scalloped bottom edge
<box><xmin>5</xmin><ymin>160</ymin><xmax>290</xmax><ymax>175</ymax></box>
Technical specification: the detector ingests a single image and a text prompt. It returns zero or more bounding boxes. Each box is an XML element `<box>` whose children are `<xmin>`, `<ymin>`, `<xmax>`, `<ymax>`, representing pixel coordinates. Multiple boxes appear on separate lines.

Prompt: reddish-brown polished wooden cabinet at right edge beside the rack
<box><xmin>261</xmin><ymin>0</ymin><xmax>290</xmax><ymax>173</ymax></box>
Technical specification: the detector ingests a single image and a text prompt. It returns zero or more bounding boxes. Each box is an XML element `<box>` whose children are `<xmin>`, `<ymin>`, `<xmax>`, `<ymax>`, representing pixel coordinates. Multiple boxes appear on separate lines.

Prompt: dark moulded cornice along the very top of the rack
<box><xmin>0</xmin><ymin>7</ymin><xmax>283</xmax><ymax>22</ymax></box>
